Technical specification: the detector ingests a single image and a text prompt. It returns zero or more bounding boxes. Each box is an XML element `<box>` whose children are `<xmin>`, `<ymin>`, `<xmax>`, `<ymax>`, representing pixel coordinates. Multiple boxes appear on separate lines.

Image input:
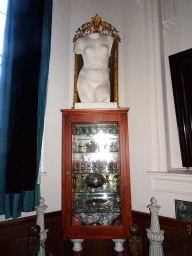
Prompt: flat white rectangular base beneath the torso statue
<box><xmin>74</xmin><ymin>102</ymin><xmax>117</xmax><ymax>109</ymax></box>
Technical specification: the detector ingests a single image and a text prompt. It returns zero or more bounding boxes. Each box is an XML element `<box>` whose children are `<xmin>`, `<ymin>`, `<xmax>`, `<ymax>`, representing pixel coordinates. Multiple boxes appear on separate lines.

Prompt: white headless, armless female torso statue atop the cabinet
<box><xmin>74</xmin><ymin>33</ymin><xmax>113</xmax><ymax>102</ymax></box>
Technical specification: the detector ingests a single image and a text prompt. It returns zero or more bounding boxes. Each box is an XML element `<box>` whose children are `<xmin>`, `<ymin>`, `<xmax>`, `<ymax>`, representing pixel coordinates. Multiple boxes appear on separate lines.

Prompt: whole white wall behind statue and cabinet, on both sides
<box><xmin>0</xmin><ymin>0</ymin><xmax>192</xmax><ymax>220</ymax></box>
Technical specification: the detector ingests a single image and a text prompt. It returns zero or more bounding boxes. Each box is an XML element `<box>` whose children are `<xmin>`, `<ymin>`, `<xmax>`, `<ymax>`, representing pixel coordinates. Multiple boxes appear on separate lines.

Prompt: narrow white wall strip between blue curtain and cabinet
<box><xmin>41</xmin><ymin>0</ymin><xmax>70</xmax><ymax>212</ymax></box>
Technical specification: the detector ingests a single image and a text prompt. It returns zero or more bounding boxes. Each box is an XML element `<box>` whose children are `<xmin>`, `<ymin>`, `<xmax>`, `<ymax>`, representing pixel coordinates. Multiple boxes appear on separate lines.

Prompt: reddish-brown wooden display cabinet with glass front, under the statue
<box><xmin>61</xmin><ymin>108</ymin><xmax>132</xmax><ymax>239</ymax></box>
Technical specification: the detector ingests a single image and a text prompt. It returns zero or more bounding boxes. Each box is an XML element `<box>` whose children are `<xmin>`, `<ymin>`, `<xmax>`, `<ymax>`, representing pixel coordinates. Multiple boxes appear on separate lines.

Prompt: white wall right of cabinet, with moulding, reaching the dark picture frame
<box><xmin>123</xmin><ymin>0</ymin><xmax>192</xmax><ymax>218</ymax></box>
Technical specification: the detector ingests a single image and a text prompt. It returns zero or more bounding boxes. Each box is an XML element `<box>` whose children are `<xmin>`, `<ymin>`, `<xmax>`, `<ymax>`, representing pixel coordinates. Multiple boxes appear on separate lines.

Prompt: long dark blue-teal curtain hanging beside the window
<box><xmin>0</xmin><ymin>0</ymin><xmax>52</xmax><ymax>218</ymax></box>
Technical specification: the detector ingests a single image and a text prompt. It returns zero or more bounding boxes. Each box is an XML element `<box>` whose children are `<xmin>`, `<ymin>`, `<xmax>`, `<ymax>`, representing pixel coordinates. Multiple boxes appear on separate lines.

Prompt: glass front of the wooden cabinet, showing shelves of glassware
<box><xmin>72</xmin><ymin>123</ymin><xmax>121</xmax><ymax>226</ymax></box>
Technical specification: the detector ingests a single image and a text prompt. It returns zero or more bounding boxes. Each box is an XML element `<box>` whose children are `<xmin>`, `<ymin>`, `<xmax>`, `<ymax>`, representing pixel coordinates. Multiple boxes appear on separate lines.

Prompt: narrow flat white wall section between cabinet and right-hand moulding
<box><xmin>120</xmin><ymin>0</ymin><xmax>153</xmax><ymax>216</ymax></box>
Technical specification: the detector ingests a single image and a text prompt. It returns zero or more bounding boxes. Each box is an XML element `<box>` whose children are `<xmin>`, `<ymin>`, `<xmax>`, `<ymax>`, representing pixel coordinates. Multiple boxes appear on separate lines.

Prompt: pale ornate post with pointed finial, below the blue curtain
<box><xmin>35</xmin><ymin>197</ymin><xmax>49</xmax><ymax>256</ymax></box>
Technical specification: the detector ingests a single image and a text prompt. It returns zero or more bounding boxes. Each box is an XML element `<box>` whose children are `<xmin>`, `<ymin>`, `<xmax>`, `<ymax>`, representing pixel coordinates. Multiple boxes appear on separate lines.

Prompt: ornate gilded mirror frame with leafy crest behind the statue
<box><xmin>73</xmin><ymin>14</ymin><xmax>121</xmax><ymax>106</ymax></box>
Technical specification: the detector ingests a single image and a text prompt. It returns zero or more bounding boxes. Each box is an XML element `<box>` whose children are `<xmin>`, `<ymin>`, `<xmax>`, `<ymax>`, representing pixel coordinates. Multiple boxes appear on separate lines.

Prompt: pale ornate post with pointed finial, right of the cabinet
<box><xmin>146</xmin><ymin>197</ymin><xmax>164</xmax><ymax>256</ymax></box>
